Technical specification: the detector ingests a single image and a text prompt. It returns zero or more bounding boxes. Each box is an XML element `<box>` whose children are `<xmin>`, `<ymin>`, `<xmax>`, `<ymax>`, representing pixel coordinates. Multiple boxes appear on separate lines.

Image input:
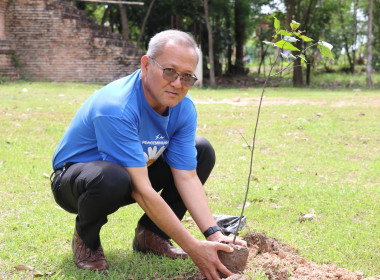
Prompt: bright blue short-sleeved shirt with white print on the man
<box><xmin>52</xmin><ymin>70</ymin><xmax>197</xmax><ymax>170</ymax></box>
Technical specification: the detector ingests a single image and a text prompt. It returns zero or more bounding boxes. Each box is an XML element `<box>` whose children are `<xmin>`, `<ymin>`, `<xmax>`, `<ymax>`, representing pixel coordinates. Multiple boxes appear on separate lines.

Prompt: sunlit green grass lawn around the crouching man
<box><xmin>0</xmin><ymin>82</ymin><xmax>380</xmax><ymax>279</ymax></box>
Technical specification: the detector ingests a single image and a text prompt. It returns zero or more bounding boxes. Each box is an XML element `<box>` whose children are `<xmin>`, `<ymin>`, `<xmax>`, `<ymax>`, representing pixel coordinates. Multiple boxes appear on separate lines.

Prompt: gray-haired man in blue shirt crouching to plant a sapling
<box><xmin>52</xmin><ymin>30</ymin><xmax>246</xmax><ymax>279</ymax></box>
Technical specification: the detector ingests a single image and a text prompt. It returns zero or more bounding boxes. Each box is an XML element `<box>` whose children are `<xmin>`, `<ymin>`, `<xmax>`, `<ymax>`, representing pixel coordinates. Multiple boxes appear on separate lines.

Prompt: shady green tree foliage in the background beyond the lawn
<box><xmin>72</xmin><ymin>0</ymin><xmax>380</xmax><ymax>86</ymax></box>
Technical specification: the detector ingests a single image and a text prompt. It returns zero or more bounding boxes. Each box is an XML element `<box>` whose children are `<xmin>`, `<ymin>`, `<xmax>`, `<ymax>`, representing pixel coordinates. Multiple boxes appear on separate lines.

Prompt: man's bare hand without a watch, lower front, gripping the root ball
<box><xmin>187</xmin><ymin>238</ymin><xmax>233</xmax><ymax>280</ymax></box>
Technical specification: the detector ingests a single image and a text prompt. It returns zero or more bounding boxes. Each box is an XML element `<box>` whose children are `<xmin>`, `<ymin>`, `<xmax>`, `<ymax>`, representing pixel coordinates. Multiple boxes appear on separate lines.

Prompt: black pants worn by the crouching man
<box><xmin>51</xmin><ymin>137</ymin><xmax>215</xmax><ymax>250</ymax></box>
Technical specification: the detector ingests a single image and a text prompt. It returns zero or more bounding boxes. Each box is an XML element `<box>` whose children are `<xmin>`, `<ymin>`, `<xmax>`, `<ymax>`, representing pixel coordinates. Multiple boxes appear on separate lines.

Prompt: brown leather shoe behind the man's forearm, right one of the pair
<box><xmin>133</xmin><ymin>224</ymin><xmax>188</xmax><ymax>259</ymax></box>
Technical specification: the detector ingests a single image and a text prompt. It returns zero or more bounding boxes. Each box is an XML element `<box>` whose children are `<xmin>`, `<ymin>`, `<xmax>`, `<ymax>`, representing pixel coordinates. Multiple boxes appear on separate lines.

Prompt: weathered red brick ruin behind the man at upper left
<box><xmin>0</xmin><ymin>0</ymin><xmax>143</xmax><ymax>83</ymax></box>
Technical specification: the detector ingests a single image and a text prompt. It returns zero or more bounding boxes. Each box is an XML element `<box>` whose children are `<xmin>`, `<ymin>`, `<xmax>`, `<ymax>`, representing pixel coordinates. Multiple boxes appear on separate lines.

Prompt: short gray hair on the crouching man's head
<box><xmin>146</xmin><ymin>29</ymin><xmax>199</xmax><ymax>63</ymax></box>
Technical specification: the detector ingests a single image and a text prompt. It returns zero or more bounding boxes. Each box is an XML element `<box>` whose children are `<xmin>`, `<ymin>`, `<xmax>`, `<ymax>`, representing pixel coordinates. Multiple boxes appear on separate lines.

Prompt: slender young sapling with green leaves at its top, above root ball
<box><xmin>233</xmin><ymin>16</ymin><xmax>334</xmax><ymax>244</ymax></box>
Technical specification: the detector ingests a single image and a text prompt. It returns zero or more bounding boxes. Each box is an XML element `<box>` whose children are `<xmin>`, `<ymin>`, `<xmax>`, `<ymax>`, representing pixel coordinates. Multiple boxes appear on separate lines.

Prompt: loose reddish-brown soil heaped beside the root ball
<box><xmin>186</xmin><ymin>233</ymin><xmax>380</xmax><ymax>280</ymax></box>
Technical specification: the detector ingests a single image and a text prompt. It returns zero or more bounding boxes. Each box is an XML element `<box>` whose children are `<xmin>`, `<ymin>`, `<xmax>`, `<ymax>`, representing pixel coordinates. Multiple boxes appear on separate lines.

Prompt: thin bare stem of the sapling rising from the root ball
<box><xmin>232</xmin><ymin>54</ymin><xmax>280</xmax><ymax>244</ymax></box>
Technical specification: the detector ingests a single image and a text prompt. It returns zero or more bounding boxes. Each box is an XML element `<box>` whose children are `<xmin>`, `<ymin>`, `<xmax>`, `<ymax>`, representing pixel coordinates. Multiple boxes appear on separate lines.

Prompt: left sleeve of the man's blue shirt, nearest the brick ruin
<box><xmin>93</xmin><ymin>116</ymin><xmax>146</xmax><ymax>167</ymax></box>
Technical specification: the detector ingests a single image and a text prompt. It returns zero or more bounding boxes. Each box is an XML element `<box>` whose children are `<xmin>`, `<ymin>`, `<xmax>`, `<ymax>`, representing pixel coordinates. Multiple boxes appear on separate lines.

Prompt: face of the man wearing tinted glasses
<box><xmin>141</xmin><ymin>42</ymin><xmax>197</xmax><ymax>115</ymax></box>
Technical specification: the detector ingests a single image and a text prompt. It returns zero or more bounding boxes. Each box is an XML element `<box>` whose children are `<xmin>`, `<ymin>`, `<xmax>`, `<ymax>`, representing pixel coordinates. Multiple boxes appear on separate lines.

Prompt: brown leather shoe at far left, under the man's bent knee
<box><xmin>71</xmin><ymin>230</ymin><xmax>108</xmax><ymax>272</ymax></box>
